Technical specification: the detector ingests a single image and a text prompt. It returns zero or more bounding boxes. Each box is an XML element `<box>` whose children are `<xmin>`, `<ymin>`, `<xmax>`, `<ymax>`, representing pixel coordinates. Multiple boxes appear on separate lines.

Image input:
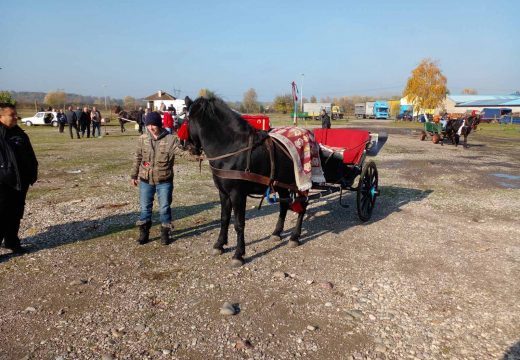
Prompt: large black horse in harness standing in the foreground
<box><xmin>185</xmin><ymin>97</ymin><xmax>316</xmax><ymax>266</ymax></box>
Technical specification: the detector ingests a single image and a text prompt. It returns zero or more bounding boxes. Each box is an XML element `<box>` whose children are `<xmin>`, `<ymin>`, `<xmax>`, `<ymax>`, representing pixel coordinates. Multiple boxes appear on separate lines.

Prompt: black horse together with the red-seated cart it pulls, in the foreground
<box><xmin>182</xmin><ymin>97</ymin><xmax>386</xmax><ymax>266</ymax></box>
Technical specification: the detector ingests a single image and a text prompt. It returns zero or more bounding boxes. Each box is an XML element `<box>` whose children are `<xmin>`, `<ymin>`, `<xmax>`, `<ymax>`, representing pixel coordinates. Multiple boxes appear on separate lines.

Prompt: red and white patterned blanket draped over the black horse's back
<box><xmin>269</xmin><ymin>126</ymin><xmax>325</xmax><ymax>191</ymax></box>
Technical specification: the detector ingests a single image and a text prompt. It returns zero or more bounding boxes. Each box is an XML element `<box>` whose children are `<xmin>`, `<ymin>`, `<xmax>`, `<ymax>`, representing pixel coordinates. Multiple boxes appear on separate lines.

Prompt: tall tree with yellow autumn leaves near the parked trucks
<box><xmin>403</xmin><ymin>59</ymin><xmax>448</xmax><ymax>112</ymax></box>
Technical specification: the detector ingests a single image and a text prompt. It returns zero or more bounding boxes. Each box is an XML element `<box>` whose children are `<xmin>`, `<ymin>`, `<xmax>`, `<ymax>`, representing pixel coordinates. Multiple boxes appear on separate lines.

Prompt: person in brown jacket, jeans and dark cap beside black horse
<box><xmin>130</xmin><ymin>112</ymin><xmax>181</xmax><ymax>245</ymax></box>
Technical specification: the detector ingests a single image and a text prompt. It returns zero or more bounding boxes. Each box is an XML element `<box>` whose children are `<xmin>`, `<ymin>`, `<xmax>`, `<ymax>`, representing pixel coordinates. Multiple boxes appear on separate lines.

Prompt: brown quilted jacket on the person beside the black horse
<box><xmin>130</xmin><ymin>129</ymin><xmax>182</xmax><ymax>185</ymax></box>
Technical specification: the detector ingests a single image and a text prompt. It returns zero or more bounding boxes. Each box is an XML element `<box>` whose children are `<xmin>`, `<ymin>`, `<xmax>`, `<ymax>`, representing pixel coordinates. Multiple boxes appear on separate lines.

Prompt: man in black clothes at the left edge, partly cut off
<box><xmin>0</xmin><ymin>103</ymin><xmax>38</xmax><ymax>254</ymax></box>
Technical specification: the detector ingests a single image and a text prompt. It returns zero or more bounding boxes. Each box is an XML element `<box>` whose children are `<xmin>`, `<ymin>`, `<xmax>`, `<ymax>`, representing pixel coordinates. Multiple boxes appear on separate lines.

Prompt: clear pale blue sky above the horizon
<box><xmin>0</xmin><ymin>0</ymin><xmax>520</xmax><ymax>101</ymax></box>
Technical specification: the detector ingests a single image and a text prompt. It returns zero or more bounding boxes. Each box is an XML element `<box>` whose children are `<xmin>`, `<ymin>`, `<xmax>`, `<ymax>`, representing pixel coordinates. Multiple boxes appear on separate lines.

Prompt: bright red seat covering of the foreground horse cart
<box><xmin>314</xmin><ymin>129</ymin><xmax>370</xmax><ymax>164</ymax></box>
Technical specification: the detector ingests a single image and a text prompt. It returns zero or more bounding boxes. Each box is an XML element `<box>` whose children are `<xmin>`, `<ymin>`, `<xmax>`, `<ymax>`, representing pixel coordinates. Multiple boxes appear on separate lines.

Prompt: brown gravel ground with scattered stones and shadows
<box><xmin>0</xmin><ymin>122</ymin><xmax>520</xmax><ymax>359</ymax></box>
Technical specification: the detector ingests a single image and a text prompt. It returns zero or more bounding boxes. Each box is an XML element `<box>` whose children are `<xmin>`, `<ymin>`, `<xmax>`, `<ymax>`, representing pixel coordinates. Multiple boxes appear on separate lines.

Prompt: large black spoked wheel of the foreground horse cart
<box><xmin>357</xmin><ymin>161</ymin><xmax>379</xmax><ymax>221</ymax></box>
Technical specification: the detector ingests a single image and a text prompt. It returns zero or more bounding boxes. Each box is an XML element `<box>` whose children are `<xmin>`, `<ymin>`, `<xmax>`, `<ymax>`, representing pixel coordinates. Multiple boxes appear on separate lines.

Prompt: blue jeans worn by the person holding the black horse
<box><xmin>139</xmin><ymin>181</ymin><xmax>173</xmax><ymax>225</ymax></box>
